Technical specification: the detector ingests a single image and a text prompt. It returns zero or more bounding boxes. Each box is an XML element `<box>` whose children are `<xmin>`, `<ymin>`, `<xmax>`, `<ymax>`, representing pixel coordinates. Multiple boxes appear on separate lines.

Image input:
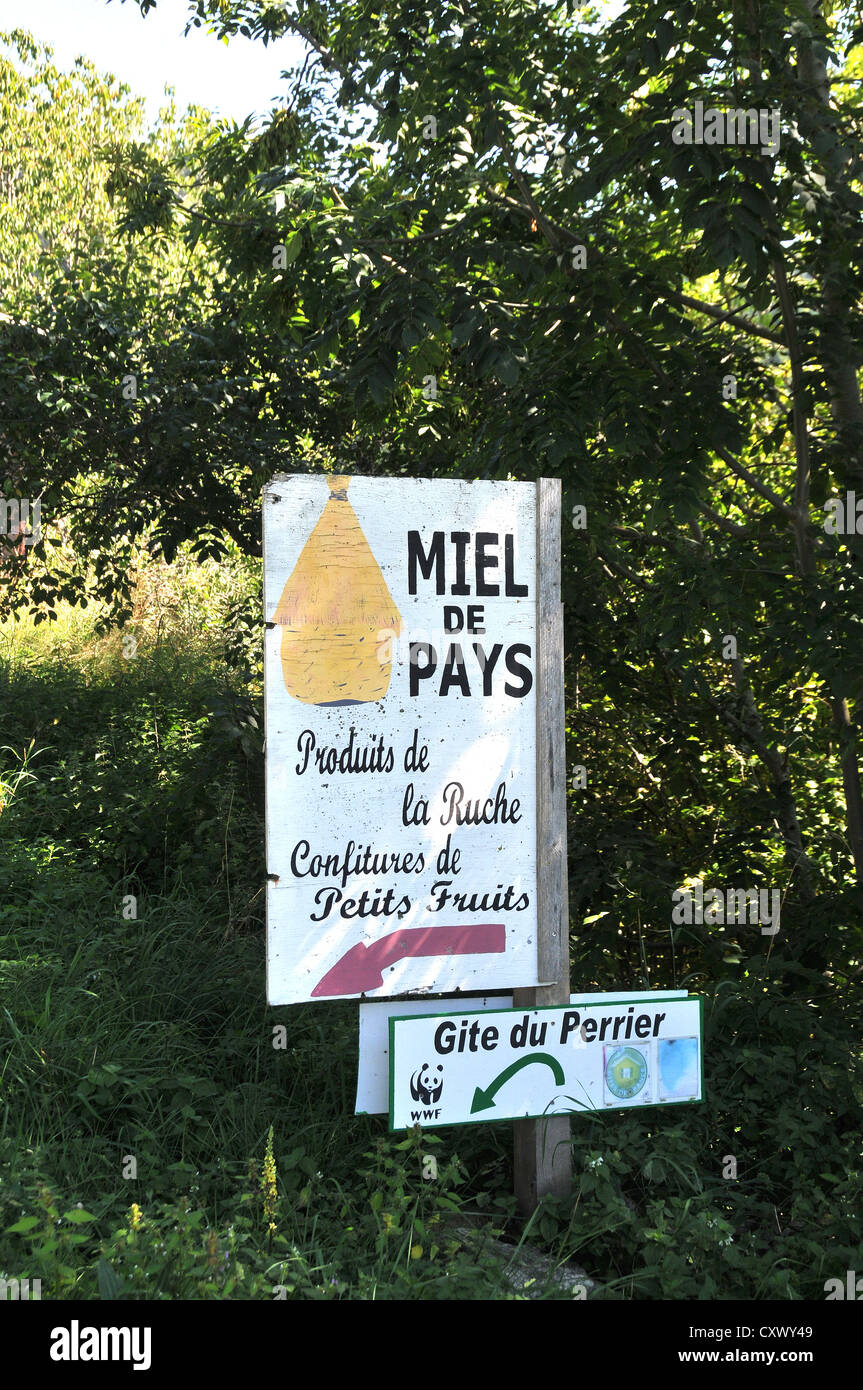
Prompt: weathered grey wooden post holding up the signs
<box><xmin>513</xmin><ymin>478</ymin><xmax>573</xmax><ymax>1216</ymax></box>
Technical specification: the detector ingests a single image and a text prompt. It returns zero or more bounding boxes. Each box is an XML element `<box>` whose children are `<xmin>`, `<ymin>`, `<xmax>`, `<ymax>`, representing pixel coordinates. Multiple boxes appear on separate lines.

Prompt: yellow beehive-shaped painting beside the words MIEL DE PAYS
<box><xmin>274</xmin><ymin>477</ymin><xmax>402</xmax><ymax>705</ymax></box>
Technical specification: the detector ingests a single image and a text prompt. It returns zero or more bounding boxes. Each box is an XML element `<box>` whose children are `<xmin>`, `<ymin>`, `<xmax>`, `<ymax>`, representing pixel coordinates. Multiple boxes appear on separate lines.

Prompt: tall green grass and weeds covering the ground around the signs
<box><xmin>0</xmin><ymin>556</ymin><xmax>863</xmax><ymax>1298</ymax></box>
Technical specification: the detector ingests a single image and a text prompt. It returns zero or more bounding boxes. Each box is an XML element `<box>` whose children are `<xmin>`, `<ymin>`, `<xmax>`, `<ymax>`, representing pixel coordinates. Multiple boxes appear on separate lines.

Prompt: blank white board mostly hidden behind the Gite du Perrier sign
<box><xmin>354</xmin><ymin>990</ymin><xmax>688</xmax><ymax>1115</ymax></box>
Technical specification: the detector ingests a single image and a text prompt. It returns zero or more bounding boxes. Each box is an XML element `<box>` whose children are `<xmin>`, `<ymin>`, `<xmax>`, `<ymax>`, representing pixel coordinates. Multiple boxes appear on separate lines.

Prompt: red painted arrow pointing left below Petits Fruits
<box><xmin>311</xmin><ymin>922</ymin><xmax>506</xmax><ymax>999</ymax></box>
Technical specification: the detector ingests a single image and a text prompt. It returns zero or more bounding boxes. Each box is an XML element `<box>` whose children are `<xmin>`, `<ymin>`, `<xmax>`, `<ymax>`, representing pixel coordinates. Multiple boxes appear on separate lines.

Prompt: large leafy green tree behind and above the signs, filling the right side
<box><xmin>1</xmin><ymin>0</ymin><xmax>863</xmax><ymax>970</ymax></box>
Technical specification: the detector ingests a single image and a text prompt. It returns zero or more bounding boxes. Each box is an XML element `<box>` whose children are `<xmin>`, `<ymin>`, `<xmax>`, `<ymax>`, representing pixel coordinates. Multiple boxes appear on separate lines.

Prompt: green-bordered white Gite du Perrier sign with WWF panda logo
<box><xmin>389</xmin><ymin>997</ymin><xmax>703</xmax><ymax>1130</ymax></box>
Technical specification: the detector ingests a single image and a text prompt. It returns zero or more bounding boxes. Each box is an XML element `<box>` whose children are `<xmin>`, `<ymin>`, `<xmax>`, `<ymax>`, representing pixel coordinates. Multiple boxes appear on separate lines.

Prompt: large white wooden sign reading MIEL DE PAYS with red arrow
<box><xmin>264</xmin><ymin>475</ymin><xmax>543</xmax><ymax>1004</ymax></box>
